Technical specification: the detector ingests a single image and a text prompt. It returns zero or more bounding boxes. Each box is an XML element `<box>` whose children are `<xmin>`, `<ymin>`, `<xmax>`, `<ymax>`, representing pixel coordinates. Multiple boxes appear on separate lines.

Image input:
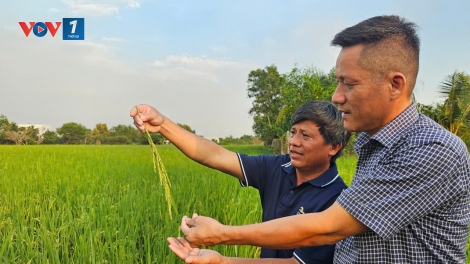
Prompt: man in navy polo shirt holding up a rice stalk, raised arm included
<box><xmin>131</xmin><ymin>101</ymin><xmax>349</xmax><ymax>263</ymax></box>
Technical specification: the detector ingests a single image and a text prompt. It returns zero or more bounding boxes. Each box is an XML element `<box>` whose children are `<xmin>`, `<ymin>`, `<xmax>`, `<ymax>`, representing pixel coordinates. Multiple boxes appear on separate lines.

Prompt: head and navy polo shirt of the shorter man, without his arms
<box><xmin>239</xmin><ymin>101</ymin><xmax>348</xmax><ymax>263</ymax></box>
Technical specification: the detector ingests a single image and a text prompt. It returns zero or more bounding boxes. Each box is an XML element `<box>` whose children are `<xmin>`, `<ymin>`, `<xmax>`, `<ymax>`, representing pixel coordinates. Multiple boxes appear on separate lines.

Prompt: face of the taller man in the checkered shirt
<box><xmin>332</xmin><ymin>45</ymin><xmax>392</xmax><ymax>136</ymax></box>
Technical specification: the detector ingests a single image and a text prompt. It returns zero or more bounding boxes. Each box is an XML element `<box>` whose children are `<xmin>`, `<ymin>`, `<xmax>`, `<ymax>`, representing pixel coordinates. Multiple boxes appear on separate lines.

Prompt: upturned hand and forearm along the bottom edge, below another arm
<box><xmin>167</xmin><ymin>237</ymin><xmax>299</xmax><ymax>264</ymax></box>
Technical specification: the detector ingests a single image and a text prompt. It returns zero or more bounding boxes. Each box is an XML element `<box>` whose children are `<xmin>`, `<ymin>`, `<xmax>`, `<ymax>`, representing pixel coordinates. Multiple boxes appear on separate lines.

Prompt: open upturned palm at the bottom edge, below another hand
<box><xmin>167</xmin><ymin>237</ymin><xmax>223</xmax><ymax>264</ymax></box>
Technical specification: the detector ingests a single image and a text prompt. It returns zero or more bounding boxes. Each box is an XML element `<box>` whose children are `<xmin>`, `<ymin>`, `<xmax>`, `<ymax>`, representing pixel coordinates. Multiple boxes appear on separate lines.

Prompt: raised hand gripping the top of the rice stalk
<box><xmin>130</xmin><ymin>104</ymin><xmax>165</xmax><ymax>132</ymax></box>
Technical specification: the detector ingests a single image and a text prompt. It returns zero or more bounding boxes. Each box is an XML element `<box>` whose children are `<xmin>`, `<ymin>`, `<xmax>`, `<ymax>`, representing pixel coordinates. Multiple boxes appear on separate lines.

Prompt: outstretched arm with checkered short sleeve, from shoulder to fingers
<box><xmin>182</xmin><ymin>141</ymin><xmax>462</xmax><ymax>249</ymax></box>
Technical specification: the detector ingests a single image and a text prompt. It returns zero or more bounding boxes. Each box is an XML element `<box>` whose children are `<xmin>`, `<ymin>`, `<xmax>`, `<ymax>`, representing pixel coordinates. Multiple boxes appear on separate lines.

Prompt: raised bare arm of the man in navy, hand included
<box><xmin>130</xmin><ymin>105</ymin><xmax>243</xmax><ymax>180</ymax></box>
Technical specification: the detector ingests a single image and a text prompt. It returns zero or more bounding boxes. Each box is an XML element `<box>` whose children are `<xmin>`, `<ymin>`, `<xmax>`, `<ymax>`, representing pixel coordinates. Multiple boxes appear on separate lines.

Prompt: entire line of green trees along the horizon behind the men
<box><xmin>0</xmin><ymin>65</ymin><xmax>470</xmax><ymax>151</ymax></box>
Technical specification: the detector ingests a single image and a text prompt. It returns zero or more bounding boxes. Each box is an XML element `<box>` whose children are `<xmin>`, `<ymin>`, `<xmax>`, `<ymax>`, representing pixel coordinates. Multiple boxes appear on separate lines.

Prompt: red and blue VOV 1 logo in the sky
<box><xmin>18</xmin><ymin>18</ymin><xmax>85</xmax><ymax>40</ymax></box>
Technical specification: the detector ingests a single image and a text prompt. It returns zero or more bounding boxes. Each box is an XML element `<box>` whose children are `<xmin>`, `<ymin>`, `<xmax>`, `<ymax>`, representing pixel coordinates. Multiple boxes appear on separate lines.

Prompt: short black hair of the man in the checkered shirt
<box><xmin>331</xmin><ymin>15</ymin><xmax>420</xmax><ymax>92</ymax></box>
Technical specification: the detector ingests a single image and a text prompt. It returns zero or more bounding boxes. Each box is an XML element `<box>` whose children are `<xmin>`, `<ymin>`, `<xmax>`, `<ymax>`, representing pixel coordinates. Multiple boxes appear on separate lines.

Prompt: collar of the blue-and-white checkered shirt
<box><xmin>354</xmin><ymin>104</ymin><xmax>419</xmax><ymax>153</ymax></box>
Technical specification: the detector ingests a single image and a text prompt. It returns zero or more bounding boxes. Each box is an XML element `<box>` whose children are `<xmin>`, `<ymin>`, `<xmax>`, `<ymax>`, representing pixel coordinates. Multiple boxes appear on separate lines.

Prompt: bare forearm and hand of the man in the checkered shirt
<box><xmin>181</xmin><ymin>202</ymin><xmax>369</xmax><ymax>249</ymax></box>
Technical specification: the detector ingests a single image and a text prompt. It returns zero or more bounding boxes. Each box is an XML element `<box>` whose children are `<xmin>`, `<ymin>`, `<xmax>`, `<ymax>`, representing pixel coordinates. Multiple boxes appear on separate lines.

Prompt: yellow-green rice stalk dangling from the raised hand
<box><xmin>135</xmin><ymin>106</ymin><xmax>174</xmax><ymax>220</ymax></box>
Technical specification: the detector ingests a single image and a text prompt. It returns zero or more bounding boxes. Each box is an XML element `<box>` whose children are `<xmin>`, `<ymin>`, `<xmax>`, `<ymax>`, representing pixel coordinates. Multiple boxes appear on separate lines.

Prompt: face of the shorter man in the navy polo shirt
<box><xmin>289</xmin><ymin>120</ymin><xmax>339</xmax><ymax>173</ymax></box>
